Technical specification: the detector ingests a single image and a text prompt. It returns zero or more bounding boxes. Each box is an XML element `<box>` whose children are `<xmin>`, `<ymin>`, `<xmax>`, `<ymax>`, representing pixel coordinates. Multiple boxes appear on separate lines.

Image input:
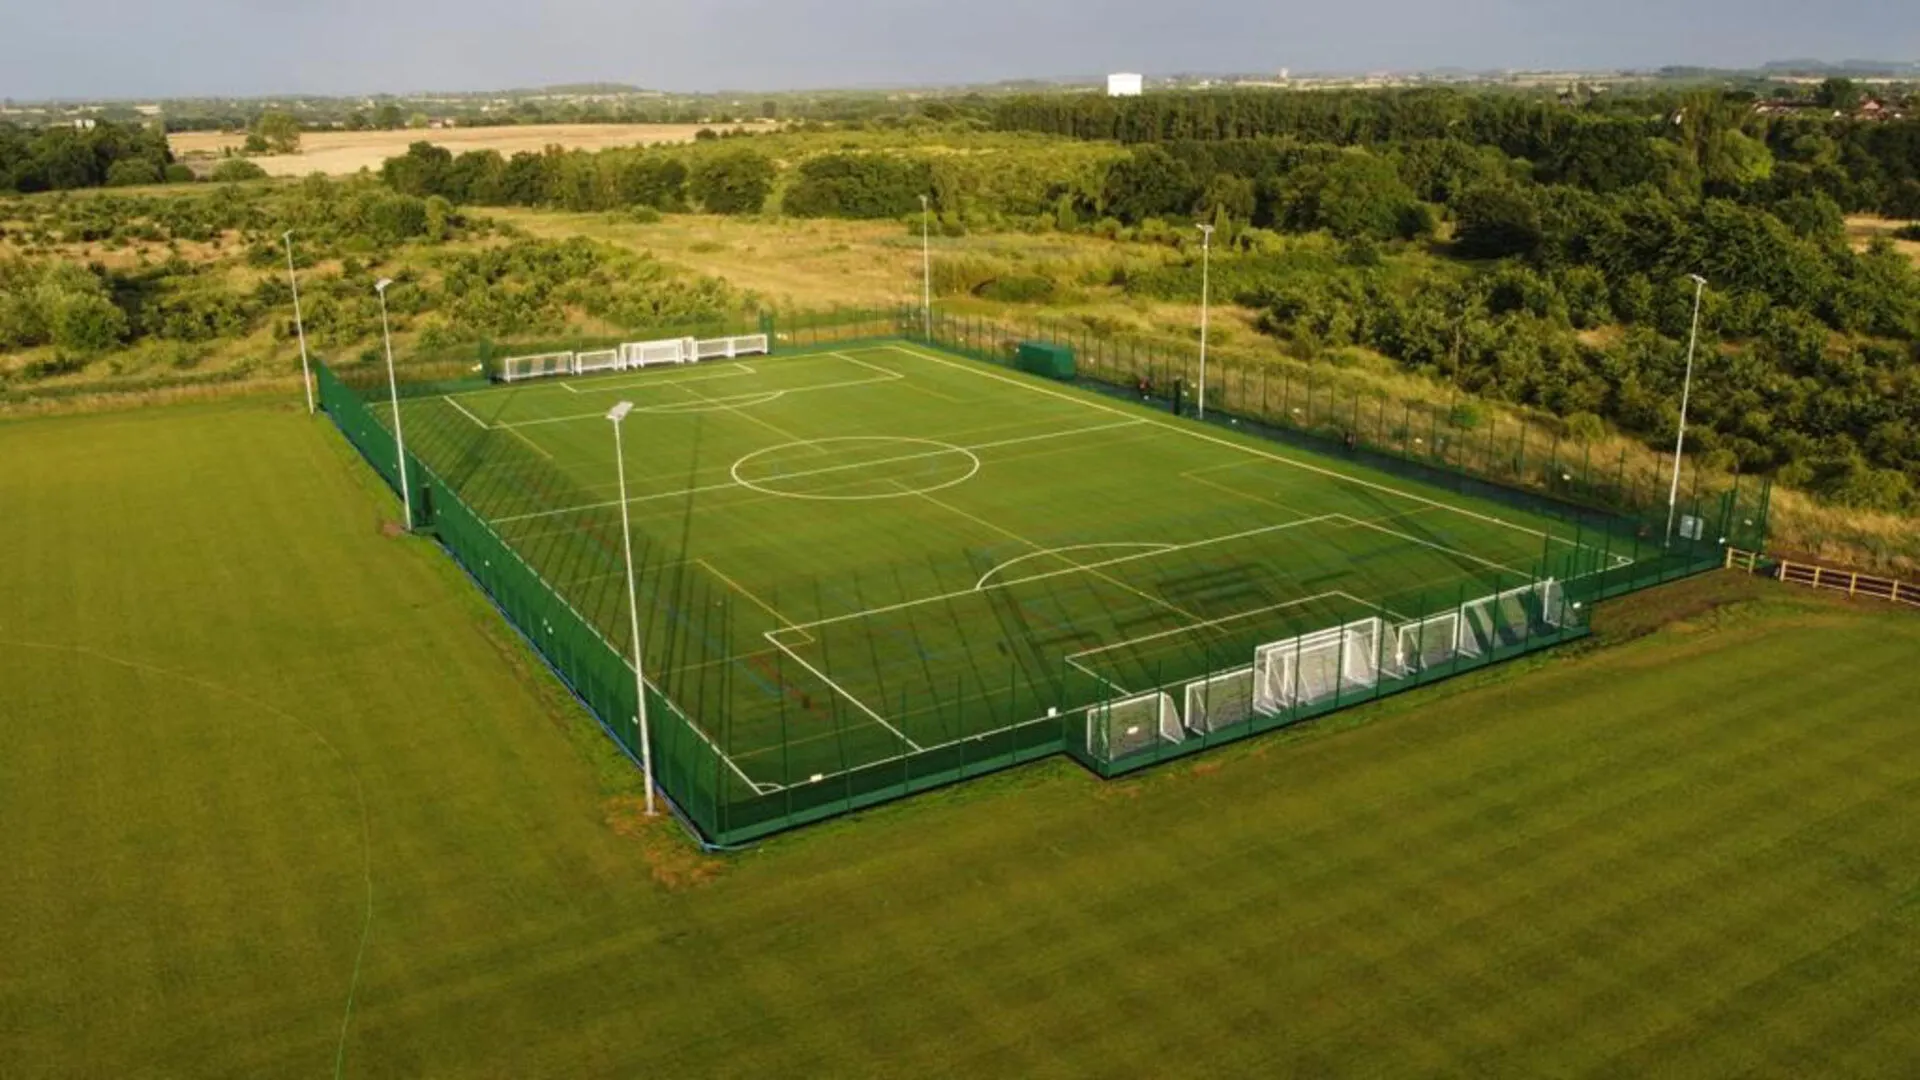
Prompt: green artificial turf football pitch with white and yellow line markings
<box><xmin>397</xmin><ymin>342</ymin><xmax>1624</xmax><ymax>794</ymax></box>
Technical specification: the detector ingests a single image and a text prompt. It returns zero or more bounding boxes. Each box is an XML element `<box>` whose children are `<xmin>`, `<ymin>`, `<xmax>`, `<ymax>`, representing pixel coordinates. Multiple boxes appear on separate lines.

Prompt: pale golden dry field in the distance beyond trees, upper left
<box><xmin>167</xmin><ymin>123</ymin><xmax>774</xmax><ymax>177</ymax></box>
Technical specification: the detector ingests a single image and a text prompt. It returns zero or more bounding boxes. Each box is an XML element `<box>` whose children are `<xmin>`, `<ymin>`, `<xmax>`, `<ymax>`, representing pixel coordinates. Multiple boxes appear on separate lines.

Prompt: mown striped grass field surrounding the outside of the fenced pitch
<box><xmin>0</xmin><ymin>404</ymin><xmax>1920</xmax><ymax>1078</ymax></box>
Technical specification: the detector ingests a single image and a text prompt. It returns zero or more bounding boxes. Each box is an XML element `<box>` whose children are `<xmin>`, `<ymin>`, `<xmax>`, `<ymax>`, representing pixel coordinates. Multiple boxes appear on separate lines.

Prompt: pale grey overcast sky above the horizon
<box><xmin>0</xmin><ymin>0</ymin><xmax>1920</xmax><ymax>98</ymax></box>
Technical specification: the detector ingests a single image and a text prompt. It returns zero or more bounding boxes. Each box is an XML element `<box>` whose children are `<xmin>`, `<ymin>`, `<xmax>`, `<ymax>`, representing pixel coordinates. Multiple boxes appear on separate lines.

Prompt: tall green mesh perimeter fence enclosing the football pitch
<box><xmin>317</xmin><ymin>309</ymin><xmax>1768</xmax><ymax>844</ymax></box>
